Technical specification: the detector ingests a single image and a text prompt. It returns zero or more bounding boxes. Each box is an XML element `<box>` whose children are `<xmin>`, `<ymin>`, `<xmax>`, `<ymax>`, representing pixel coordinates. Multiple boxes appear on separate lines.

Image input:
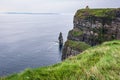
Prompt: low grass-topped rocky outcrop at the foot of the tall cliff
<box><xmin>62</xmin><ymin>40</ymin><xmax>90</xmax><ymax>60</ymax></box>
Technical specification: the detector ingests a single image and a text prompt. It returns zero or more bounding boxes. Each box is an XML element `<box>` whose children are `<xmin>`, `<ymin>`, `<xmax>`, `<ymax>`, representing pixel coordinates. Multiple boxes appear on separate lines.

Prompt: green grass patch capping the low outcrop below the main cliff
<box><xmin>65</xmin><ymin>40</ymin><xmax>91</xmax><ymax>51</ymax></box>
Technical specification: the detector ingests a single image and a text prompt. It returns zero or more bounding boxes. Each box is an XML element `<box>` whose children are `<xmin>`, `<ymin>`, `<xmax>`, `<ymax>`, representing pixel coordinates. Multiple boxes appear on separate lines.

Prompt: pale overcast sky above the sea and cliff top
<box><xmin>0</xmin><ymin>0</ymin><xmax>120</xmax><ymax>13</ymax></box>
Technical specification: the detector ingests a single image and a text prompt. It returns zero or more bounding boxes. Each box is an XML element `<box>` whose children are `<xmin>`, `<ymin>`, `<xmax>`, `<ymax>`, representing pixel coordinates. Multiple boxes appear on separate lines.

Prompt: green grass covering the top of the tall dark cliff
<box><xmin>75</xmin><ymin>8</ymin><xmax>117</xmax><ymax>19</ymax></box>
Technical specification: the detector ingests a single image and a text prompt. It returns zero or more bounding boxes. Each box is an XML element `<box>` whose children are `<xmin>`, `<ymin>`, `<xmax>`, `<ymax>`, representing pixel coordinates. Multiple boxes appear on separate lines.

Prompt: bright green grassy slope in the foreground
<box><xmin>1</xmin><ymin>41</ymin><xmax>120</xmax><ymax>80</ymax></box>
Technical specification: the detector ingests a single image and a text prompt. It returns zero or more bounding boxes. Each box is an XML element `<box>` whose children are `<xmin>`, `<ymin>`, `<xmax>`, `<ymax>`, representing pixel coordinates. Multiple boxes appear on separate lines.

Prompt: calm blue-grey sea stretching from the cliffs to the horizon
<box><xmin>0</xmin><ymin>14</ymin><xmax>73</xmax><ymax>76</ymax></box>
